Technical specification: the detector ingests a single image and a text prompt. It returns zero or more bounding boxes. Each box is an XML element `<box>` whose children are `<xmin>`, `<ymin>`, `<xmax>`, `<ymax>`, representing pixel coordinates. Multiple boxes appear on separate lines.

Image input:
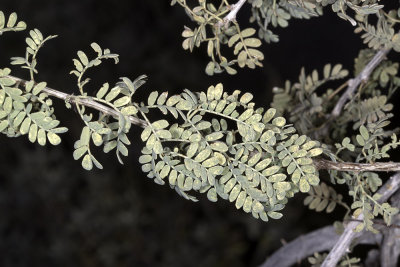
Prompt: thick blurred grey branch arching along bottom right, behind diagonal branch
<box><xmin>260</xmin><ymin>226</ymin><xmax>382</xmax><ymax>267</ymax></box>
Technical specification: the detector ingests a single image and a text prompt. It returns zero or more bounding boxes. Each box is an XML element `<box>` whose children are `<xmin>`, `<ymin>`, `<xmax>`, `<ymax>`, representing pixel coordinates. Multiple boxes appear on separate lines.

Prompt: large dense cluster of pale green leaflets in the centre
<box><xmin>139</xmin><ymin>84</ymin><xmax>323</xmax><ymax>221</ymax></box>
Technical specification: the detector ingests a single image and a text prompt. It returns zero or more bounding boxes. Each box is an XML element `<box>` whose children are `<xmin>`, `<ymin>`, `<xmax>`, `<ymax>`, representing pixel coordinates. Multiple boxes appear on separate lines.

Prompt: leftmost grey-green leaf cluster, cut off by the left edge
<box><xmin>0</xmin><ymin>26</ymin><xmax>67</xmax><ymax>146</ymax></box>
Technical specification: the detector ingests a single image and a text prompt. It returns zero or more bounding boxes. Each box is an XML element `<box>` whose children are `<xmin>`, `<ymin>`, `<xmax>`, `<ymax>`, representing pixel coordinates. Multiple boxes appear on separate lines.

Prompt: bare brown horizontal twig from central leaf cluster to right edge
<box><xmin>313</xmin><ymin>159</ymin><xmax>400</xmax><ymax>172</ymax></box>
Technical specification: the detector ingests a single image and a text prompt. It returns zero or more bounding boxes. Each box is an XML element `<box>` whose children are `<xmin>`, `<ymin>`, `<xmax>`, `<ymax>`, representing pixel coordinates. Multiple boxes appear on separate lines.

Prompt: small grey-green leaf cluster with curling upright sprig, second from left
<box><xmin>66</xmin><ymin>43</ymin><xmax>146</xmax><ymax>170</ymax></box>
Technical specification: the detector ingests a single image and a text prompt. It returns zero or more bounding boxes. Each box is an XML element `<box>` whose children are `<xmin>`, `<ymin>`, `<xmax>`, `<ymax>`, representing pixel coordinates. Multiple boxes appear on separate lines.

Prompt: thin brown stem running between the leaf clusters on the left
<box><xmin>7</xmin><ymin>76</ymin><xmax>147</xmax><ymax>128</ymax></box>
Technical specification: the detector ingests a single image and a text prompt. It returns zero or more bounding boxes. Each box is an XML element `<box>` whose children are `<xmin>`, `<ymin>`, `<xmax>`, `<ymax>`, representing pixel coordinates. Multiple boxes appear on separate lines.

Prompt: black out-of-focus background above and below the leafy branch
<box><xmin>0</xmin><ymin>0</ymin><xmax>376</xmax><ymax>266</ymax></box>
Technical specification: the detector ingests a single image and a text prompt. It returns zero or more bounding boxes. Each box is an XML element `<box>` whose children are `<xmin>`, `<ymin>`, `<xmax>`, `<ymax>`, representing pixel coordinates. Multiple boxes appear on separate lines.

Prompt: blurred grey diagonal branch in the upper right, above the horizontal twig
<box><xmin>331</xmin><ymin>49</ymin><xmax>390</xmax><ymax>118</ymax></box>
